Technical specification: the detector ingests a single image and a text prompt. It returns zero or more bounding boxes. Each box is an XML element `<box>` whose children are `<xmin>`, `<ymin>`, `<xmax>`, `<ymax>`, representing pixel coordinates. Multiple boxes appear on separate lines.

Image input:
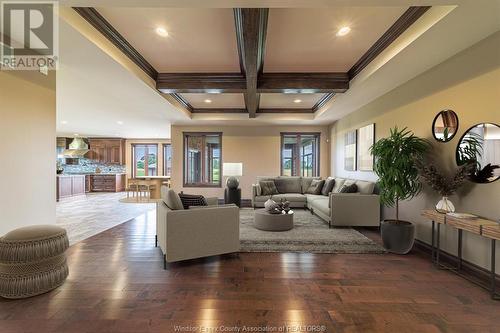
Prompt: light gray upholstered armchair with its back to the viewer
<box><xmin>156</xmin><ymin>186</ymin><xmax>240</xmax><ymax>269</ymax></box>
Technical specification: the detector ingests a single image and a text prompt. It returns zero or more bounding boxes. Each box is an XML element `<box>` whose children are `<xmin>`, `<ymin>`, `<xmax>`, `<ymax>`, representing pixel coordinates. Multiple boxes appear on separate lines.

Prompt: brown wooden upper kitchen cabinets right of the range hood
<box><xmin>85</xmin><ymin>138</ymin><xmax>125</xmax><ymax>165</ymax></box>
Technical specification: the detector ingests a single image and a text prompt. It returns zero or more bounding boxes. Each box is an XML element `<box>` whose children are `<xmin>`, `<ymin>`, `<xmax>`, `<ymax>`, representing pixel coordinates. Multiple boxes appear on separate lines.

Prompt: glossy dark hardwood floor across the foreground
<box><xmin>0</xmin><ymin>209</ymin><xmax>500</xmax><ymax>333</ymax></box>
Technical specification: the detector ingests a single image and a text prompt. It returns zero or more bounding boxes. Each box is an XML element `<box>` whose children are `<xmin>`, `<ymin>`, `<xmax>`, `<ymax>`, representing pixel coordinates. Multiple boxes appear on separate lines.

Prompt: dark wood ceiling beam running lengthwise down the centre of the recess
<box><xmin>234</xmin><ymin>8</ymin><xmax>269</xmax><ymax>118</ymax></box>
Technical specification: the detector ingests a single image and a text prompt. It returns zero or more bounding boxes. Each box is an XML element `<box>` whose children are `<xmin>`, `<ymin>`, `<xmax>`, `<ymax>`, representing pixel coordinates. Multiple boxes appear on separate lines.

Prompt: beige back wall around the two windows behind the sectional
<box><xmin>172</xmin><ymin>126</ymin><xmax>330</xmax><ymax>199</ymax></box>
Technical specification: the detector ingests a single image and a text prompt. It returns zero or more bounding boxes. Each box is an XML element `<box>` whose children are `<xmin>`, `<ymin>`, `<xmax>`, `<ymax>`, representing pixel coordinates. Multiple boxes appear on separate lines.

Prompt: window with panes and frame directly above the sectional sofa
<box><xmin>281</xmin><ymin>133</ymin><xmax>320</xmax><ymax>177</ymax></box>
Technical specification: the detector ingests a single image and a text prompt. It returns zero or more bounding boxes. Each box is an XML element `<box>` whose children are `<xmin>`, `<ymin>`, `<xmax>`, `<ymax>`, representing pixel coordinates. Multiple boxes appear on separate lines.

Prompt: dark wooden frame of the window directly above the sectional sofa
<box><xmin>280</xmin><ymin>132</ymin><xmax>321</xmax><ymax>177</ymax></box>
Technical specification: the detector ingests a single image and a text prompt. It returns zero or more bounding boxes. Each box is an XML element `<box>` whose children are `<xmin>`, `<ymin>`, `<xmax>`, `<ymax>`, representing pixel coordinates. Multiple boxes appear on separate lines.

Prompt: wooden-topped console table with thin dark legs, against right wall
<box><xmin>422</xmin><ymin>209</ymin><xmax>500</xmax><ymax>300</ymax></box>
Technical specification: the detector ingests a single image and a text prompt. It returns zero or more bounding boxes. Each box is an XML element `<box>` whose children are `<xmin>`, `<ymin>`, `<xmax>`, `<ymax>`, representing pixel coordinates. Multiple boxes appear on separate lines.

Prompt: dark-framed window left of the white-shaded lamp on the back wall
<box><xmin>184</xmin><ymin>133</ymin><xmax>222</xmax><ymax>187</ymax></box>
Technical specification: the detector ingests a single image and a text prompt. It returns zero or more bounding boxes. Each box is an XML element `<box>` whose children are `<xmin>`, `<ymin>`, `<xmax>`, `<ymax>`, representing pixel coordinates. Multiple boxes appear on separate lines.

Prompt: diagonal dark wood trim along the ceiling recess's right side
<box><xmin>348</xmin><ymin>6</ymin><xmax>431</xmax><ymax>80</ymax></box>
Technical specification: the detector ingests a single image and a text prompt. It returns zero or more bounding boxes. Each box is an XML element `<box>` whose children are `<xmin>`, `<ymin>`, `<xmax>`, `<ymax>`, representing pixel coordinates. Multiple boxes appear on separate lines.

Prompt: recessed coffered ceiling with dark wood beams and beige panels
<box><xmin>75</xmin><ymin>7</ymin><xmax>430</xmax><ymax>118</ymax></box>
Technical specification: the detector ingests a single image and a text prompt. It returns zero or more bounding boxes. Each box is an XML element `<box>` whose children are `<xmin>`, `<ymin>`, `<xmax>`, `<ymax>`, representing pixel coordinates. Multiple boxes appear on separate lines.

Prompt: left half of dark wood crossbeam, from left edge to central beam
<box><xmin>156</xmin><ymin>73</ymin><xmax>246</xmax><ymax>94</ymax></box>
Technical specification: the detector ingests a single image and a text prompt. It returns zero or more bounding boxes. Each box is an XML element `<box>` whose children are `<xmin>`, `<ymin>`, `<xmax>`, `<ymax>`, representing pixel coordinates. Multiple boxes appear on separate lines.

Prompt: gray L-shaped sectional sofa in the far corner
<box><xmin>252</xmin><ymin>176</ymin><xmax>380</xmax><ymax>227</ymax></box>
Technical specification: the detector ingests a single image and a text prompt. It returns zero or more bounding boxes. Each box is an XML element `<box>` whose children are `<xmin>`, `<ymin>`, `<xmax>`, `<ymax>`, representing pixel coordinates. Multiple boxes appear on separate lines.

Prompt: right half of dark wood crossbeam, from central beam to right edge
<box><xmin>257</xmin><ymin>73</ymin><xmax>349</xmax><ymax>93</ymax></box>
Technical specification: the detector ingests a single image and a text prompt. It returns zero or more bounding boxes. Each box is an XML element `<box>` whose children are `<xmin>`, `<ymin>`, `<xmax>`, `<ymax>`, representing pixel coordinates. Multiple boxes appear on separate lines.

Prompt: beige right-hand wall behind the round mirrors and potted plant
<box><xmin>331</xmin><ymin>33</ymin><xmax>500</xmax><ymax>272</ymax></box>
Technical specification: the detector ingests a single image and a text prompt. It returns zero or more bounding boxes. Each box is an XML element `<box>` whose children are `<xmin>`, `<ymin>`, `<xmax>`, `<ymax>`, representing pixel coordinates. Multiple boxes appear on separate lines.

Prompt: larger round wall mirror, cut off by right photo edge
<box><xmin>456</xmin><ymin>123</ymin><xmax>500</xmax><ymax>183</ymax></box>
